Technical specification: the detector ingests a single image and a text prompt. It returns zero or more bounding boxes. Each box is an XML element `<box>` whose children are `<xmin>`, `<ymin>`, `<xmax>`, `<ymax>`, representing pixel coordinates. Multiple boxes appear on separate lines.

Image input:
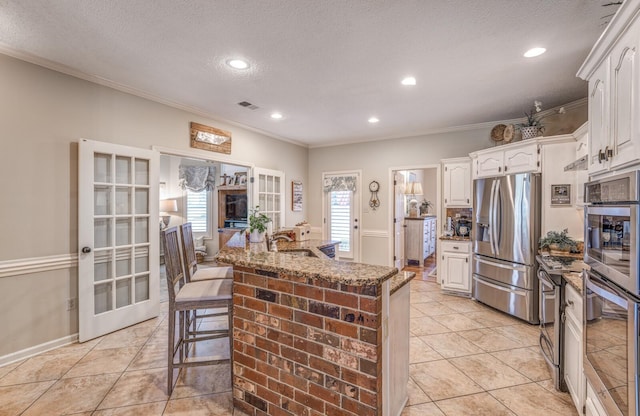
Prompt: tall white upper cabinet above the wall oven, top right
<box><xmin>578</xmin><ymin>1</ymin><xmax>640</xmax><ymax>175</ymax></box>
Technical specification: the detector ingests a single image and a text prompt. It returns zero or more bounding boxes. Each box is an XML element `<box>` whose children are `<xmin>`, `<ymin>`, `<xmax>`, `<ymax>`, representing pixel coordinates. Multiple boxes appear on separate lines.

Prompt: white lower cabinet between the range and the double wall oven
<box><xmin>564</xmin><ymin>284</ymin><xmax>586</xmax><ymax>413</ymax></box>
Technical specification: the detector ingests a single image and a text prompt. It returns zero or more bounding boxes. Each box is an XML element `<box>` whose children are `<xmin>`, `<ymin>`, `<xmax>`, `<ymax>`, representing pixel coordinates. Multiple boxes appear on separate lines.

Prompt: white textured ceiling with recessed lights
<box><xmin>0</xmin><ymin>0</ymin><xmax>615</xmax><ymax>147</ymax></box>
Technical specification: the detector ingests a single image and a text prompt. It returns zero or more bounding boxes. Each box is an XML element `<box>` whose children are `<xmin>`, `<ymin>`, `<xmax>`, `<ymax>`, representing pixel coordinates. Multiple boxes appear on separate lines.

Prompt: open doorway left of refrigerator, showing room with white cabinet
<box><xmin>391</xmin><ymin>165</ymin><xmax>441</xmax><ymax>280</ymax></box>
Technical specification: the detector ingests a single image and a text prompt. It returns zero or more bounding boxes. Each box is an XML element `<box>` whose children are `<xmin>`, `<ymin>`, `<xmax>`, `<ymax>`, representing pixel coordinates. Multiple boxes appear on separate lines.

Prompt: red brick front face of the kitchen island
<box><xmin>233</xmin><ymin>266</ymin><xmax>382</xmax><ymax>416</ymax></box>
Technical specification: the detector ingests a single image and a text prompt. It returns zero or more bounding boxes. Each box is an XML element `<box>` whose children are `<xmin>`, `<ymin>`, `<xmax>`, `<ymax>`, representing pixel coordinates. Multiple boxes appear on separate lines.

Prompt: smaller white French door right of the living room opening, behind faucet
<box><xmin>250</xmin><ymin>167</ymin><xmax>285</xmax><ymax>231</ymax></box>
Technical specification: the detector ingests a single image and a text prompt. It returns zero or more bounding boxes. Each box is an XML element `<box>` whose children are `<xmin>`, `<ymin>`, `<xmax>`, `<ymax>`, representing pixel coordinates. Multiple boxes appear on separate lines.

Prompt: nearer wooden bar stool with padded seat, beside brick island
<box><xmin>161</xmin><ymin>227</ymin><xmax>233</xmax><ymax>396</ymax></box>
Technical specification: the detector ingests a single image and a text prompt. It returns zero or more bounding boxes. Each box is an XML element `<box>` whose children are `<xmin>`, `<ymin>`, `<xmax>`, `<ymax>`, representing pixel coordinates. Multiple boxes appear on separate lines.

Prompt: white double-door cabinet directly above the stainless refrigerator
<box><xmin>471</xmin><ymin>139</ymin><xmax>540</xmax><ymax>179</ymax></box>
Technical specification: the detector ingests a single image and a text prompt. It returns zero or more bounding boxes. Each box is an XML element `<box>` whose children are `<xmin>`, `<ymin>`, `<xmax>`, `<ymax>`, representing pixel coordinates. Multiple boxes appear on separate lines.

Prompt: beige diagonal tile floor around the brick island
<box><xmin>0</xmin><ymin>274</ymin><xmax>577</xmax><ymax>416</ymax></box>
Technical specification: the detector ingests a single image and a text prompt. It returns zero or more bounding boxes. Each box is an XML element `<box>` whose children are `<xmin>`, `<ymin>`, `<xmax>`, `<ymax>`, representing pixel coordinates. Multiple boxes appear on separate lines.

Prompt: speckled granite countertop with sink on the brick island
<box><xmin>216</xmin><ymin>233</ymin><xmax>402</xmax><ymax>289</ymax></box>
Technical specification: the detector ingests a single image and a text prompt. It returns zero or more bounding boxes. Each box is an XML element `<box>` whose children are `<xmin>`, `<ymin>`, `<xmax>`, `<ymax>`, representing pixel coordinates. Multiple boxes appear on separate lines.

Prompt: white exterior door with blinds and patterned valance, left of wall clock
<box><xmin>323</xmin><ymin>172</ymin><xmax>360</xmax><ymax>262</ymax></box>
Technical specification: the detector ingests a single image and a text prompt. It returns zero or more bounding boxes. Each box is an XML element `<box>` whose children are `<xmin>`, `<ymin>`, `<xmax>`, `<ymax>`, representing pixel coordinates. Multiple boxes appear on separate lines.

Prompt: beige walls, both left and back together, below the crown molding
<box><xmin>0</xmin><ymin>49</ymin><xmax>584</xmax><ymax>363</ymax></box>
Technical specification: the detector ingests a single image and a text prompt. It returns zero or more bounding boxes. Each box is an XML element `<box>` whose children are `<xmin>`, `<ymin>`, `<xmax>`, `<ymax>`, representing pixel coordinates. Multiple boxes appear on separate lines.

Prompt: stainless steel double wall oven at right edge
<box><xmin>584</xmin><ymin>171</ymin><xmax>640</xmax><ymax>415</ymax></box>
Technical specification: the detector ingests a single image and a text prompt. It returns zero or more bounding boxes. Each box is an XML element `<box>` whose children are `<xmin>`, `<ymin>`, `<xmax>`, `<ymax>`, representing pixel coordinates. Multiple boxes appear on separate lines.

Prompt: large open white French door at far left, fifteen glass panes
<box><xmin>78</xmin><ymin>139</ymin><xmax>160</xmax><ymax>342</ymax></box>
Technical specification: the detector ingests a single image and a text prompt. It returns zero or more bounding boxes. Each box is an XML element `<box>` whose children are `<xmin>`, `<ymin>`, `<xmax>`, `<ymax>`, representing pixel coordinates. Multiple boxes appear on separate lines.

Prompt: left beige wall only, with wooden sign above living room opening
<box><xmin>0</xmin><ymin>55</ymin><xmax>309</xmax><ymax>362</ymax></box>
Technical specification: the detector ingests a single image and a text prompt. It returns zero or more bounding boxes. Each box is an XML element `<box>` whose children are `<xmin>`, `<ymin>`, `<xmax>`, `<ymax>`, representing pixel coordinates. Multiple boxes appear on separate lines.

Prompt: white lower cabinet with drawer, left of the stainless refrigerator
<box><xmin>438</xmin><ymin>241</ymin><xmax>471</xmax><ymax>293</ymax></box>
